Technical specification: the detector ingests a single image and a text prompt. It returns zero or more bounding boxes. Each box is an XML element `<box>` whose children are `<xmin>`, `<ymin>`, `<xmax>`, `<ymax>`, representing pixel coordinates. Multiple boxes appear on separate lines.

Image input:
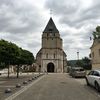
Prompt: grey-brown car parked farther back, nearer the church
<box><xmin>69</xmin><ymin>67</ymin><xmax>86</xmax><ymax>77</ymax></box>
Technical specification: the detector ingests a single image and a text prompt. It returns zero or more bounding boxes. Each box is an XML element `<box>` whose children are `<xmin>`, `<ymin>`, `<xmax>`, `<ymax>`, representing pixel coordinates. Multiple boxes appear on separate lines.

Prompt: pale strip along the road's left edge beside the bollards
<box><xmin>5</xmin><ymin>75</ymin><xmax>45</xmax><ymax>100</ymax></box>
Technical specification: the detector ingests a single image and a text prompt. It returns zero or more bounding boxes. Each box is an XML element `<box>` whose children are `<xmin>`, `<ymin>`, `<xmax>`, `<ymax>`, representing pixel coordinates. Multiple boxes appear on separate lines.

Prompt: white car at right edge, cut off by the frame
<box><xmin>86</xmin><ymin>70</ymin><xmax>100</xmax><ymax>91</ymax></box>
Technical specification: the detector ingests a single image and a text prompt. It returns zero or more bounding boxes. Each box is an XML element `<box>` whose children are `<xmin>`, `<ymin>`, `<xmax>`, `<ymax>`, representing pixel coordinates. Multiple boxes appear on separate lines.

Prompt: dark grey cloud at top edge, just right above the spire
<box><xmin>45</xmin><ymin>0</ymin><xmax>80</xmax><ymax>15</ymax></box>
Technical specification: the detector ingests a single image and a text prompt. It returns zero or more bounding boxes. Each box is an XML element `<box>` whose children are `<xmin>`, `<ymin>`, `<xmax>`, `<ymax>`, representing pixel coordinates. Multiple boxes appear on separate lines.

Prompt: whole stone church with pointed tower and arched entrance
<box><xmin>36</xmin><ymin>17</ymin><xmax>67</xmax><ymax>73</ymax></box>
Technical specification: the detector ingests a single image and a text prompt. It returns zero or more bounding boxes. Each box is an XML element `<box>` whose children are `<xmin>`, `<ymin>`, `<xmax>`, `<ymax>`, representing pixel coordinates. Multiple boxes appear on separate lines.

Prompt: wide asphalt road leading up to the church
<box><xmin>6</xmin><ymin>73</ymin><xmax>100</xmax><ymax>100</ymax></box>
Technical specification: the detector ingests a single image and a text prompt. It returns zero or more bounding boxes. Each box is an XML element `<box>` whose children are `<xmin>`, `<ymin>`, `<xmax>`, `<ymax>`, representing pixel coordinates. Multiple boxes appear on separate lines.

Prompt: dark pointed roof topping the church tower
<box><xmin>43</xmin><ymin>18</ymin><xmax>59</xmax><ymax>33</ymax></box>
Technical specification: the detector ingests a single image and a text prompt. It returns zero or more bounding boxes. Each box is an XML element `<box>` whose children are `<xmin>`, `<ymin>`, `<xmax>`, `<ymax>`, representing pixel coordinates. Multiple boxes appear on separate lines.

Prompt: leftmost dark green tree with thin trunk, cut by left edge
<box><xmin>0</xmin><ymin>40</ymin><xmax>20</xmax><ymax>77</ymax></box>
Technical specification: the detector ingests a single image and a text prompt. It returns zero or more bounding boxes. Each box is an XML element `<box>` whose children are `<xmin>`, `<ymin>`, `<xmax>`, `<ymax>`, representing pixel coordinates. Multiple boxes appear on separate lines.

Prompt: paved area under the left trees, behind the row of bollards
<box><xmin>0</xmin><ymin>73</ymin><xmax>42</xmax><ymax>100</ymax></box>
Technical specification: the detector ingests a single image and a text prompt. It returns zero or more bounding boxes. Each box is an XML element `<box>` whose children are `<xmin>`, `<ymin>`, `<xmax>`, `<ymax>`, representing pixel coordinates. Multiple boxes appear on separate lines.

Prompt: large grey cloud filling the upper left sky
<box><xmin>0</xmin><ymin>0</ymin><xmax>42</xmax><ymax>33</ymax></box>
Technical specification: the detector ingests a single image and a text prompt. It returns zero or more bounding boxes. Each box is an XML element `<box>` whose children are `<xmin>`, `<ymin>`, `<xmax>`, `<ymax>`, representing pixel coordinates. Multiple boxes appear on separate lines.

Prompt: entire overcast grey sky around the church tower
<box><xmin>0</xmin><ymin>0</ymin><xmax>100</xmax><ymax>60</ymax></box>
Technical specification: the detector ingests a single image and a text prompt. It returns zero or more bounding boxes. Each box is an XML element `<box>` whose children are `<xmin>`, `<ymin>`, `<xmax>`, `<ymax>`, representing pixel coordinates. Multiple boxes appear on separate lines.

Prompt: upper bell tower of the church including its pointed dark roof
<box><xmin>42</xmin><ymin>18</ymin><xmax>62</xmax><ymax>49</ymax></box>
